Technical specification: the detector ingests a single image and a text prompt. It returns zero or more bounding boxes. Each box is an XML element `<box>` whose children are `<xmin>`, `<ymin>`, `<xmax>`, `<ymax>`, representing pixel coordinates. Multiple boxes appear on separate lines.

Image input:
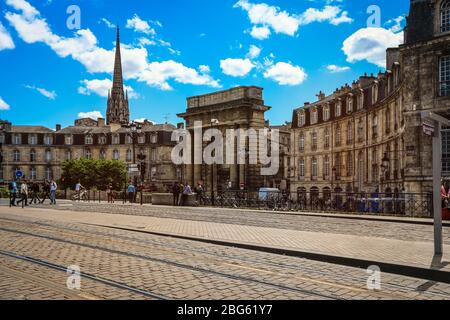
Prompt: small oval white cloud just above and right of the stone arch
<box><xmin>264</xmin><ymin>62</ymin><xmax>307</xmax><ymax>86</ymax></box>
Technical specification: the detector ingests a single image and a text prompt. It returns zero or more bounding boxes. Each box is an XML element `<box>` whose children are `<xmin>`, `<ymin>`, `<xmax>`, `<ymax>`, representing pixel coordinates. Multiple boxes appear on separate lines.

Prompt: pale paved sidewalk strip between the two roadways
<box><xmin>0</xmin><ymin>207</ymin><xmax>450</xmax><ymax>279</ymax></box>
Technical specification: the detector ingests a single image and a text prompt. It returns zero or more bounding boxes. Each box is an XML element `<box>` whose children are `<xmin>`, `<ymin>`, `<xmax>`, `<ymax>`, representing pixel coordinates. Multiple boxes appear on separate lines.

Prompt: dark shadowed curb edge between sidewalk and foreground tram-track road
<box><xmin>93</xmin><ymin>224</ymin><xmax>450</xmax><ymax>284</ymax></box>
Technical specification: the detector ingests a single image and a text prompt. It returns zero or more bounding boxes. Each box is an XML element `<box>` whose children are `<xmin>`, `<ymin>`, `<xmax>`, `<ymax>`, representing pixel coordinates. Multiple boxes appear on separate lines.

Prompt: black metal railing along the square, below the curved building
<box><xmin>199</xmin><ymin>191</ymin><xmax>433</xmax><ymax>217</ymax></box>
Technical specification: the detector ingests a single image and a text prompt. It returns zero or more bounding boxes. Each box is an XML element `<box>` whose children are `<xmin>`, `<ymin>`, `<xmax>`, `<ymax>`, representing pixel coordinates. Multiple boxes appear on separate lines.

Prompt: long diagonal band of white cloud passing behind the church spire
<box><xmin>5</xmin><ymin>0</ymin><xmax>220</xmax><ymax>90</ymax></box>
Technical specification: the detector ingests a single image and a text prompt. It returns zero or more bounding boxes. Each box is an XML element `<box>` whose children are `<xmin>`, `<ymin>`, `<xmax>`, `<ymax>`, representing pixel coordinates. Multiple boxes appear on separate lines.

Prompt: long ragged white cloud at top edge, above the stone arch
<box><xmin>234</xmin><ymin>0</ymin><xmax>353</xmax><ymax>40</ymax></box>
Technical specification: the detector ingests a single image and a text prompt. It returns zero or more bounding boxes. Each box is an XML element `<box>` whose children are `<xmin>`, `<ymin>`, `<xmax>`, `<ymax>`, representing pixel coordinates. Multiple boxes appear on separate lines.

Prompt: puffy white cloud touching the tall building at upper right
<box><xmin>342</xmin><ymin>28</ymin><xmax>403</xmax><ymax>68</ymax></box>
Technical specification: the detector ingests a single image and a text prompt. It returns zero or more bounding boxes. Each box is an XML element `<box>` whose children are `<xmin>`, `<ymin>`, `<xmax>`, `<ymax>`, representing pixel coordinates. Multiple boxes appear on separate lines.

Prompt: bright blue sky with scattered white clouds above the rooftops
<box><xmin>0</xmin><ymin>0</ymin><xmax>409</xmax><ymax>128</ymax></box>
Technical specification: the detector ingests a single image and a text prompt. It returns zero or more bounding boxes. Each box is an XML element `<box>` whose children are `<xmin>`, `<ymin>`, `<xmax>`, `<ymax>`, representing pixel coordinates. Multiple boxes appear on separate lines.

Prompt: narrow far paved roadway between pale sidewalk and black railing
<box><xmin>41</xmin><ymin>202</ymin><xmax>450</xmax><ymax>245</ymax></box>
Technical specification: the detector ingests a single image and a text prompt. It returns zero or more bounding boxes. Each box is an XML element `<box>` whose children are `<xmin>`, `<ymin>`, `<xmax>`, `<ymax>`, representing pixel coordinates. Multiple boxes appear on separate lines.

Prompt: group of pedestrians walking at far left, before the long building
<box><xmin>8</xmin><ymin>179</ymin><xmax>58</xmax><ymax>207</ymax></box>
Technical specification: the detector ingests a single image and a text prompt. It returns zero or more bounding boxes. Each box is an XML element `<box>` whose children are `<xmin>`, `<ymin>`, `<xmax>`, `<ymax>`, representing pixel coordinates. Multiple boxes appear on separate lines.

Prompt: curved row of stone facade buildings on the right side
<box><xmin>290</xmin><ymin>0</ymin><xmax>450</xmax><ymax>193</ymax></box>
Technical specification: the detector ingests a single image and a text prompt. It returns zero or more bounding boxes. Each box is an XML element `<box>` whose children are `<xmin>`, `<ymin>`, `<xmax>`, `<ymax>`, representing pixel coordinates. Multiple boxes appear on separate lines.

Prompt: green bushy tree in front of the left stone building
<box><xmin>62</xmin><ymin>159</ymin><xmax>127</xmax><ymax>191</ymax></box>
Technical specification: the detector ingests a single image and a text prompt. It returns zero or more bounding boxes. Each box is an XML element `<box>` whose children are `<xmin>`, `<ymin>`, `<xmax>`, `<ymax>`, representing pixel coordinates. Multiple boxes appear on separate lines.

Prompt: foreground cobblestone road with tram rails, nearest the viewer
<box><xmin>0</xmin><ymin>212</ymin><xmax>450</xmax><ymax>300</ymax></box>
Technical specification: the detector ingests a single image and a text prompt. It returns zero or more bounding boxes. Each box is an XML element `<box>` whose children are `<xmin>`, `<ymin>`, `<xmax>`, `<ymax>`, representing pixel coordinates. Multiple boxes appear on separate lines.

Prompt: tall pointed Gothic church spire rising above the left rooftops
<box><xmin>106</xmin><ymin>27</ymin><xmax>130</xmax><ymax>124</ymax></box>
